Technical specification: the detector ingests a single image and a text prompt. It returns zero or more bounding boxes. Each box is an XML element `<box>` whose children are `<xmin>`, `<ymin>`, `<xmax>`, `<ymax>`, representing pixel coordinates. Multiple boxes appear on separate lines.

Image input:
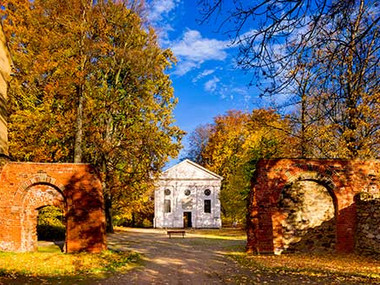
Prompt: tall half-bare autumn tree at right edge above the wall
<box><xmin>312</xmin><ymin>1</ymin><xmax>380</xmax><ymax>158</ymax></box>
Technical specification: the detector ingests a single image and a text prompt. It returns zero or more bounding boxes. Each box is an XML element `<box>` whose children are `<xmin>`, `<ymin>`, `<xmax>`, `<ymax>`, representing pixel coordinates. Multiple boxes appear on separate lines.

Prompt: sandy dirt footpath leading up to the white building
<box><xmin>100</xmin><ymin>229</ymin><xmax>249</xmax><ymax>284</ymax></box>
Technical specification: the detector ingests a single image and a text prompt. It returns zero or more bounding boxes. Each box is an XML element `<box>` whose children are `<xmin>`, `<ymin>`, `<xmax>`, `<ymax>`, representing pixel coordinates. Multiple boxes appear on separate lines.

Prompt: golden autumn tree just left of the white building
<box><xmin>79</xmin><ymin>0</ymin><xmax>182</xmax><ymax>231</ymax></box>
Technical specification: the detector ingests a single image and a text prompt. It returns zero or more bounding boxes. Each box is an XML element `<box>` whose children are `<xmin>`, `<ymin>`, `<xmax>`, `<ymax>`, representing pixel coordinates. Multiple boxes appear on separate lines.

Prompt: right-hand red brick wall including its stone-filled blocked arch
<box><xmin>247</xmin><ymin>159</ymin><xmax>380</xmax><ymax>253</ymax></box>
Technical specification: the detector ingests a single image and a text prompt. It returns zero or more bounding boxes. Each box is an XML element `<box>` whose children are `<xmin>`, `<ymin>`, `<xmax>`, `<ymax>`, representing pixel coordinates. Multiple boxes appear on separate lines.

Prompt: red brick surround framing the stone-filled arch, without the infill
<box><xmin>247</xmin><ymin>159</ymin><xmax>380</xmax><ymax>253</ymax></box>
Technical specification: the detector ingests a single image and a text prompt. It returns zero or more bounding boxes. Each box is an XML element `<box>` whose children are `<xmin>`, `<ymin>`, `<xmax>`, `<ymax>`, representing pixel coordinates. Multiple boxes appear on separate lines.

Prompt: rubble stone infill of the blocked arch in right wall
<box><xmin>275</xmin><ymin>179</ymin><xmax>336</xmax><ymax>252</ymax></box>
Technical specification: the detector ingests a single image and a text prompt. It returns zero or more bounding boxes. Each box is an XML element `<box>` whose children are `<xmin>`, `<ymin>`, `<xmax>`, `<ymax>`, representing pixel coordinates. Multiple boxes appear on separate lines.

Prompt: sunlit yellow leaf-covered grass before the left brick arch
<box><xmin>0</xmin><ymin>245</ymin><xmax>139</xmax><ymax>278</ymax></box>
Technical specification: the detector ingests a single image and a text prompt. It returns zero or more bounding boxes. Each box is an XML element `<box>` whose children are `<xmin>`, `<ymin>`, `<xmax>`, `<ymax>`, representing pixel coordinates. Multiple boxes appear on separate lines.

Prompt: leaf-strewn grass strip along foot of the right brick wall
<box><xmin>189</xmin><ymin>228</ymin><xmax>380</xmax><ymax>284</ymax></box>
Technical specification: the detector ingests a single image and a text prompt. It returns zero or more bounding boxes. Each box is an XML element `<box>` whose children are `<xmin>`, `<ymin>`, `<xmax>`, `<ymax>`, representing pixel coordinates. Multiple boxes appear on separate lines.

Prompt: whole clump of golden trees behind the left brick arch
<box><xmin>0</xmin><ymin>0</ymin><xmax>182</xmax><ymax>230</ymax></box>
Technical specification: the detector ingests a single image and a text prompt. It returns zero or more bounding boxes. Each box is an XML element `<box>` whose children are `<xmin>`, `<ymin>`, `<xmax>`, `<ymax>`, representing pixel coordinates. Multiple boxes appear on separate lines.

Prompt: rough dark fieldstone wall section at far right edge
<box><xmin>355</xmin><ymin>193</ymin><xmax>380</xmax><ymax>256</ymax></box>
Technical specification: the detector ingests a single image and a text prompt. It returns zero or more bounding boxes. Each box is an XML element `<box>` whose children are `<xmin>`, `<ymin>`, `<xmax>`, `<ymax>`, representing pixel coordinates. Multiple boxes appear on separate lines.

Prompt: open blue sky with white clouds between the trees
<box><xmin>148</xmin><ymin>0</ymin><xmax>268</xmax><ymax>164</ymax></box>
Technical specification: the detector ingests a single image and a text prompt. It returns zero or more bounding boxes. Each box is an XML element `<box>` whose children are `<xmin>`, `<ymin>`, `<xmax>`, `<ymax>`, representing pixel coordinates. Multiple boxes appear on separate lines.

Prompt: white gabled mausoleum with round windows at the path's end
<box><xmin>154</xmin><ymin>159</ymin><xmax>223</xmax><ymax>228</ymax></box>
